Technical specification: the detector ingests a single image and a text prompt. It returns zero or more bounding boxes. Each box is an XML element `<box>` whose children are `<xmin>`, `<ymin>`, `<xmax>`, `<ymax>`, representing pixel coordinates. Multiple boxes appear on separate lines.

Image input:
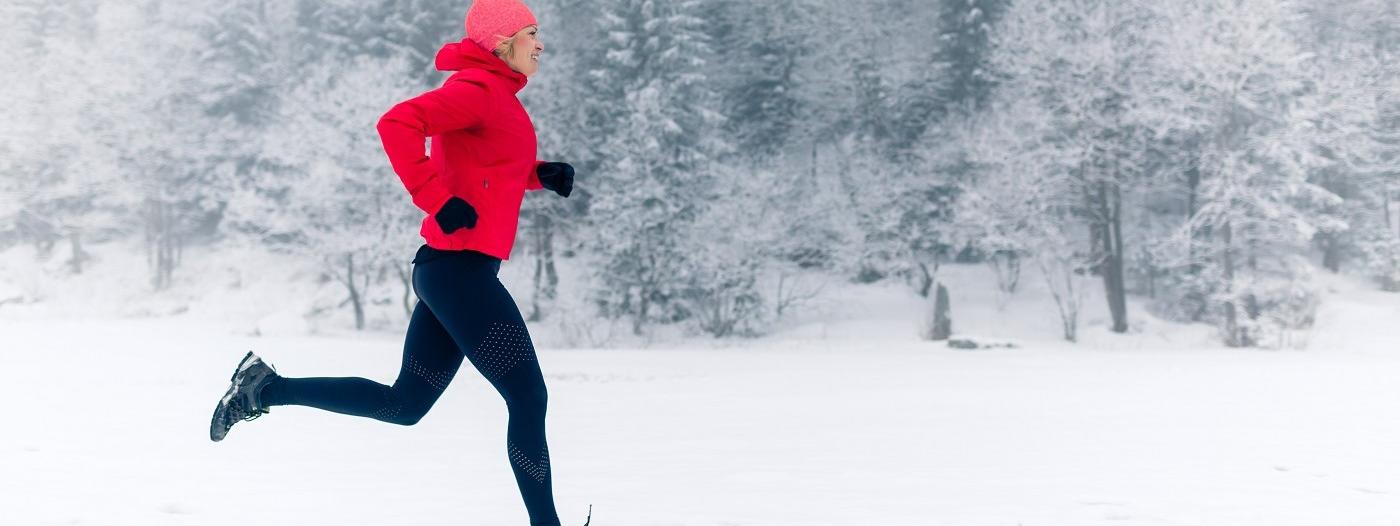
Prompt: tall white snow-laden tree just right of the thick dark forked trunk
<box><xmin>1158</xmin><ymin>0</ymin><xmax>1337</xmax><ymax>346</ymax></box>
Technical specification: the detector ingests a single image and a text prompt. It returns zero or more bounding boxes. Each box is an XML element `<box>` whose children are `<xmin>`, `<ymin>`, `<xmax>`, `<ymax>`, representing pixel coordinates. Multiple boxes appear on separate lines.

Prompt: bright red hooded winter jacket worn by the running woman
<box><xmin>378</xmin><ymin>41</ymin><xmax>540</xmax><ymax>259</ymax></box>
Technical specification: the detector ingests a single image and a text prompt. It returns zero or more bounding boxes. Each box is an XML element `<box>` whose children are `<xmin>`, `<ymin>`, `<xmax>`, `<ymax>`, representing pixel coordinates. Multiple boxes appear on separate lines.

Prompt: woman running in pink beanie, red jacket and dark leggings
<box><xmin>209</xmin><ymin>0</ymin><xmax>574</xmax><ymax>526</ymax></box>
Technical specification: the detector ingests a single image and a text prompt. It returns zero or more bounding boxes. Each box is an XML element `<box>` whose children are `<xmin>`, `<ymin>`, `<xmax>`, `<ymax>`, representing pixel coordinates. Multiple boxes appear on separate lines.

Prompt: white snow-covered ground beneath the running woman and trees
<box><xmin>0</xmin><ymin>243</ymin><xmax>1400</xmax><ymax>526</ymax></box>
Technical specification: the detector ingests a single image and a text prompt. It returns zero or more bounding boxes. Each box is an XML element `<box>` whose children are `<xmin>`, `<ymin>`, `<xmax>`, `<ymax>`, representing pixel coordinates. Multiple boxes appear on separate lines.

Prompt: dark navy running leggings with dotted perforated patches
<box><xmin>262</xmin><ymin>245</ymin><xmax>559</xmax><ymax>526</ymax></box>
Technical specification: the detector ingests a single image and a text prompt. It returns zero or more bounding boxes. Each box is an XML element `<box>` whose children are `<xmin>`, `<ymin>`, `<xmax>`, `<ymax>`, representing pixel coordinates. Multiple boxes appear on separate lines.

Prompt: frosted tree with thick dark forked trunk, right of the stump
<box><xmin>991</xmin><ymin>0</ymin><xmax>1159</xmax><ymax>333</ymax></box>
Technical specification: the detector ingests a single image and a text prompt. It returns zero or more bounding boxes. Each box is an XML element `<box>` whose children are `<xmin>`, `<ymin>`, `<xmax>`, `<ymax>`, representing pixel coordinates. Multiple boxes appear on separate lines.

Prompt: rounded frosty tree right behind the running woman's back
<box><xmin>231</xmin><ymin>56</ymin><xmax>423</xmax><ymax>329</ymax></box>
